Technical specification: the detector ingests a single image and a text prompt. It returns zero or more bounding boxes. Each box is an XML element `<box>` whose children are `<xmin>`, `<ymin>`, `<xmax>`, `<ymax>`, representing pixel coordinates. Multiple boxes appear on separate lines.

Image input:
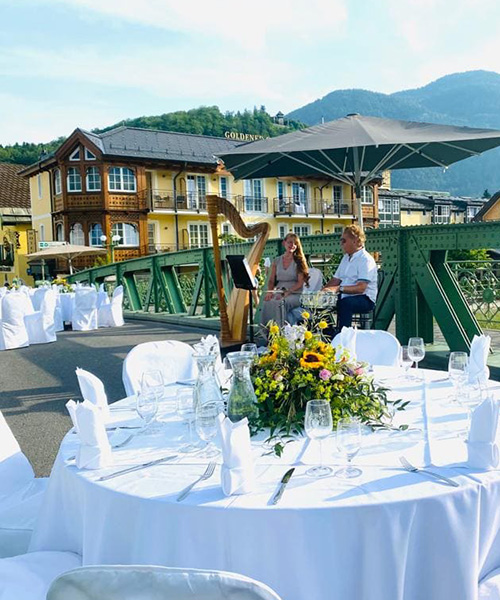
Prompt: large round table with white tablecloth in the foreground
<box><xmin>30</xmin><ymin>369</ymin><xmax>500</xmax><ymax>600</ymax></box>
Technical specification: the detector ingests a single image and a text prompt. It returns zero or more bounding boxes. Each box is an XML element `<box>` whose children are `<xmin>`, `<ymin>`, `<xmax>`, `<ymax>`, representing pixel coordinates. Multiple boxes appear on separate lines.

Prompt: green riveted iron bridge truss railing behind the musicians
<box><xmin>69</xmin><ymin>222</ymin><xmax>500</xmax><ymax>368</ymax></box>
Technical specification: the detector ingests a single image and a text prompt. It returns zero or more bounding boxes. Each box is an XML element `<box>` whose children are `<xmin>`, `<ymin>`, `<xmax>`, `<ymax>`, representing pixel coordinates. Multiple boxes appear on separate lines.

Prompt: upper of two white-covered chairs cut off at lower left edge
<box><xmin>0</xmin><ymin>412</ymin><xmax>48</xmax><ymax>556</ymax></box>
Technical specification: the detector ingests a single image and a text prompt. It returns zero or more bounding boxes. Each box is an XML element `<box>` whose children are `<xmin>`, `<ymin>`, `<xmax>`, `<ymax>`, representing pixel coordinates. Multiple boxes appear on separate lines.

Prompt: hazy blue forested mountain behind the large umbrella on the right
<box><xmin>287</xmin><ymin>71</ymin><xmax>500</xmax><ymax>196</ymax></box>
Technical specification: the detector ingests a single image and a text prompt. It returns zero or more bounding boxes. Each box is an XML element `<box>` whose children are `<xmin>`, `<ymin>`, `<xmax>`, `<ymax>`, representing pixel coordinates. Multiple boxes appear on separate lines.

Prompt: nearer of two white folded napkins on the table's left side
<box><xmin>66</xmin><ymin>400</ymin><xmax>113</xmax><ymax>469</ymax></box>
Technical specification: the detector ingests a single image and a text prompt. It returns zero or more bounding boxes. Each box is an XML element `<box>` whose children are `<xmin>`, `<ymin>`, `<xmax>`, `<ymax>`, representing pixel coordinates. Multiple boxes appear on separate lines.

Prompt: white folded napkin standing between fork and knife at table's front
<box><xmin>219</xmin><ymin>414</ymin><xmax>255</xmax><ymax>496</ymax></box>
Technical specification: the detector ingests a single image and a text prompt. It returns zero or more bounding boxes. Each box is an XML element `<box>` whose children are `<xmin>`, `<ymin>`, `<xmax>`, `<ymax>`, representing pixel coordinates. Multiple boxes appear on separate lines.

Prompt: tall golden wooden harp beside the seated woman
<box><xmin>207</xmin><ymin>195</ymin><xmax>271</xmax><ymax>345</ymax></box>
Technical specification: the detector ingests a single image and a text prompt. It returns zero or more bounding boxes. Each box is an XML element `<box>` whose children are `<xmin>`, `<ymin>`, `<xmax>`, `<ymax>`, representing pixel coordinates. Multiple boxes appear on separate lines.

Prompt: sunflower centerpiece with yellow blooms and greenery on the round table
<box><xmin>252</xmin><ymin>312</ymin><xmax>407</xmax><ymax>437</ymax></box>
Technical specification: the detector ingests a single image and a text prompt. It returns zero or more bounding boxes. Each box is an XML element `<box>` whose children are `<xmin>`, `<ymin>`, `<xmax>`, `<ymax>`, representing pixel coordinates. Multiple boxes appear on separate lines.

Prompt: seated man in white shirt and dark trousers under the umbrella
<box><xmin>323</xmin><ymin>225</ymin><xmax>377</xmax><ymax>331</ymax></box>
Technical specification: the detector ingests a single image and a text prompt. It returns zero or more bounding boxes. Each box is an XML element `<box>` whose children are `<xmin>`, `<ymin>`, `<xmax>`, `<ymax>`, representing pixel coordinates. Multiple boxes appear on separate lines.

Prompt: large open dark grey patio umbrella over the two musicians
<box><xmin>219</xmin><ymin>114</ymin><xmax>500</xmax><ymax>226</ymax></box>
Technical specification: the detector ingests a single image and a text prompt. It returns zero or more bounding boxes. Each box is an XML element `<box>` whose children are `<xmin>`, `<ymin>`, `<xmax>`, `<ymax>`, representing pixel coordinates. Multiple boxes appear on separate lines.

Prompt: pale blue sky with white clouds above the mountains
<box><xmin>0</xmin><ymin>0</ymin><xmax>500</xmax><ymax>144</ymax></box>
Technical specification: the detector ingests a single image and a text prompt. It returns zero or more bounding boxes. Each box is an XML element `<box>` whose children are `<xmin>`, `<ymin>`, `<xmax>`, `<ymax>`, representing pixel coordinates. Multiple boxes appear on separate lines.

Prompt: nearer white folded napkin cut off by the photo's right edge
<box><xmin>467</xmin><ymin>397</ymin><xmax>500</xmax><ymax>469</ymax></box>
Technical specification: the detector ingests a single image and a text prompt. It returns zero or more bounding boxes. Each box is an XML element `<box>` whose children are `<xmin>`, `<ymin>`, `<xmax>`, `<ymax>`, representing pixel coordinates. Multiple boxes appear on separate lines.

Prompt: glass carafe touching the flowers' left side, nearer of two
<box><xmin>227</xmin><ymin>352</ymin><xmax>258</xmax><ymax>423</ymax></box>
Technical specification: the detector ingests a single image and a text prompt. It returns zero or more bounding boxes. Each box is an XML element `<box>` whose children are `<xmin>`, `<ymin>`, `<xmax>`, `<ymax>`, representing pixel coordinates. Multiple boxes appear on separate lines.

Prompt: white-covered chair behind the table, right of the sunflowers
<box><xmin>332</xmin><ymin>329</ymin><xmax>401</xmax><ymax>367</ymax></box>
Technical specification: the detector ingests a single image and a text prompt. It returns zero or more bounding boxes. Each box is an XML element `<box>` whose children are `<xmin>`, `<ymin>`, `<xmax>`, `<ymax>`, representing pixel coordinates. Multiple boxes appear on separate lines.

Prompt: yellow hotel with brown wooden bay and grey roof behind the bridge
<box><xmin>22</xmin><ymin>127</ymin><xmax>380</xmax><ymax>276</ymax></box>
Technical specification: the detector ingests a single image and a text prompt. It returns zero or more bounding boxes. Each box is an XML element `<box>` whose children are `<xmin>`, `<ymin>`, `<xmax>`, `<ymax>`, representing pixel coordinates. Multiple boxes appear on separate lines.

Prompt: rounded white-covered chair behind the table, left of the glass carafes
<box><xmin>122</xmin><ymin>340</ymin><xmax>197</xmax><ymax>396</ymax></box>
